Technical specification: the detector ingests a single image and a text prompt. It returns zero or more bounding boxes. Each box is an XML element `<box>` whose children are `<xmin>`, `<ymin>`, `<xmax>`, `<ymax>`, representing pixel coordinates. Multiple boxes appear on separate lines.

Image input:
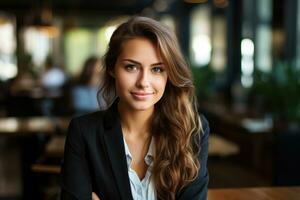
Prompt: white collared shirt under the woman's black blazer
<box><xmin>123</xmin><ymin>137</ymin><xmax>156</xmax><ymax>200</ymax></box>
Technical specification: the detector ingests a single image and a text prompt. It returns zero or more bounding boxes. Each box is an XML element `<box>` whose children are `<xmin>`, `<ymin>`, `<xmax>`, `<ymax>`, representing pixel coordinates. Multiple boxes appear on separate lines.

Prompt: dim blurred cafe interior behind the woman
<box><xmin>0</xmin><ymin>0</ymin><xmax>300</xmax><ymax>200</ymax></box>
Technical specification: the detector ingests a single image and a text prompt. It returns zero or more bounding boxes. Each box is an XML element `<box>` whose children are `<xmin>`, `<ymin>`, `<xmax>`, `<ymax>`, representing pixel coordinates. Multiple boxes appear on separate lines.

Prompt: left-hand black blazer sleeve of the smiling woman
<box><xmin>61</xmin><ymin>120</ymin><xmax>92</xmax><ymax>200</ymax></box>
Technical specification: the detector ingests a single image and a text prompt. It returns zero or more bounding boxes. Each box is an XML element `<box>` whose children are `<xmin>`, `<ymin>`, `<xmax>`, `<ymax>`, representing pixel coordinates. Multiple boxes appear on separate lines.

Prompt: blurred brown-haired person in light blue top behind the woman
<box><xmin>71</xmin><ymin>56</ymin><xmax>104</xmax><ymax>115</ymax></box>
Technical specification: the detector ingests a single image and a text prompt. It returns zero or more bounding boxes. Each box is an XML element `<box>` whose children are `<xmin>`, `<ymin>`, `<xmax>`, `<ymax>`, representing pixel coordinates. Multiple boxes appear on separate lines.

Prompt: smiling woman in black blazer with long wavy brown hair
<box><xmin>62</xmin><ymin>17</ymin><xmax>209</xmax><ymax>200</ymax></box>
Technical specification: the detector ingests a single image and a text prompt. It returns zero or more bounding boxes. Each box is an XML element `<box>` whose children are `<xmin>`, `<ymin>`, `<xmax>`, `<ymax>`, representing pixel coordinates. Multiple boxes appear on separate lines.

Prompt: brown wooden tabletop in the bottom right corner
<box><xmin>208</xmin><ymin>186</ymin><xmax>300</xmax><ymax>200</ymax></box>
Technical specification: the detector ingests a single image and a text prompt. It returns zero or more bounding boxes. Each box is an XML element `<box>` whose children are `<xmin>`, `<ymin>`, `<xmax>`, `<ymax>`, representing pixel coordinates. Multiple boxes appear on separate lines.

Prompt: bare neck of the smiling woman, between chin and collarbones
<box><xmin>118</xmin><ymin>104</ymin><xmax>154</xmax><ymax>138</ymax></box>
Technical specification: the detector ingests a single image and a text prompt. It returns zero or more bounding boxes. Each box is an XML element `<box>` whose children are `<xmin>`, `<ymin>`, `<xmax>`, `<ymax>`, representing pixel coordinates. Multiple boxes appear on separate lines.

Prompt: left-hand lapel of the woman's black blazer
<box><xmin>104</xmin><ymin>100</ymin><xmax>133</xmax><ymax>200</ymax></box>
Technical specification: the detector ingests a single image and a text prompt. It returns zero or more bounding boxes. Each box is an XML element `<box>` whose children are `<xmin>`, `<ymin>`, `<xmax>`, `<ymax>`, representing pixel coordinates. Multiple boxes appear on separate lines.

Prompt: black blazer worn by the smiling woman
<box><xmin>61</xmin><ymin>102</ymin><xmax>209</xmax><ymax>200</ymax></box>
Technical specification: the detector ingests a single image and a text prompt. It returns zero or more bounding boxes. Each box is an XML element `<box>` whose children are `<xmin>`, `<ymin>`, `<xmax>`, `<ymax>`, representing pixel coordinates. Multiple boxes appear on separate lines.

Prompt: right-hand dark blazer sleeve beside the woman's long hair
<box><xmin>176</xmin><ymin>115</ymin><xmax>210</xmax><ymax>200</ymax></box>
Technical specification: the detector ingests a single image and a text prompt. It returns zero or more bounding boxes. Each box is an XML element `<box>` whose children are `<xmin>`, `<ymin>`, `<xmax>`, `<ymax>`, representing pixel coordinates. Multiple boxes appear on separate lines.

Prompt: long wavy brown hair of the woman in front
<box><xmin>99</xmin><ymin>17</ymin><xmax>202</xmax><ymax>200</ymax></box>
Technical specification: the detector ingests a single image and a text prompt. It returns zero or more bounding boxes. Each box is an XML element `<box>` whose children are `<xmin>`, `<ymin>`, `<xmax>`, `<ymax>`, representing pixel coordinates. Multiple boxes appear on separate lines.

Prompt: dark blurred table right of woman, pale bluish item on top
<box><xmin>202</xmin><ymin>102</ymin><xmax>278</xmax><ymax>180</ymax></box>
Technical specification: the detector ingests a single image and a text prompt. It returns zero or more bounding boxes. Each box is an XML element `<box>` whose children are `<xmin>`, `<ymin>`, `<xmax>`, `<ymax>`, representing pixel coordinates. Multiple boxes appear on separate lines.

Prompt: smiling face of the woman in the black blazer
<box><xmin>112</xmin><ymin>38</ymin><xmax>168</xmax><ymax>111</ymax></box>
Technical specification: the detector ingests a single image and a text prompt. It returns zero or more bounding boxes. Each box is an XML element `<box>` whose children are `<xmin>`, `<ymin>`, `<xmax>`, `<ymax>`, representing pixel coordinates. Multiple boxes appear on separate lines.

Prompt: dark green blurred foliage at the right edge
<box><xmin>252</xmin><ymin>62</ymin><xmax>300</xmax><ymax>122</ymax></box>
